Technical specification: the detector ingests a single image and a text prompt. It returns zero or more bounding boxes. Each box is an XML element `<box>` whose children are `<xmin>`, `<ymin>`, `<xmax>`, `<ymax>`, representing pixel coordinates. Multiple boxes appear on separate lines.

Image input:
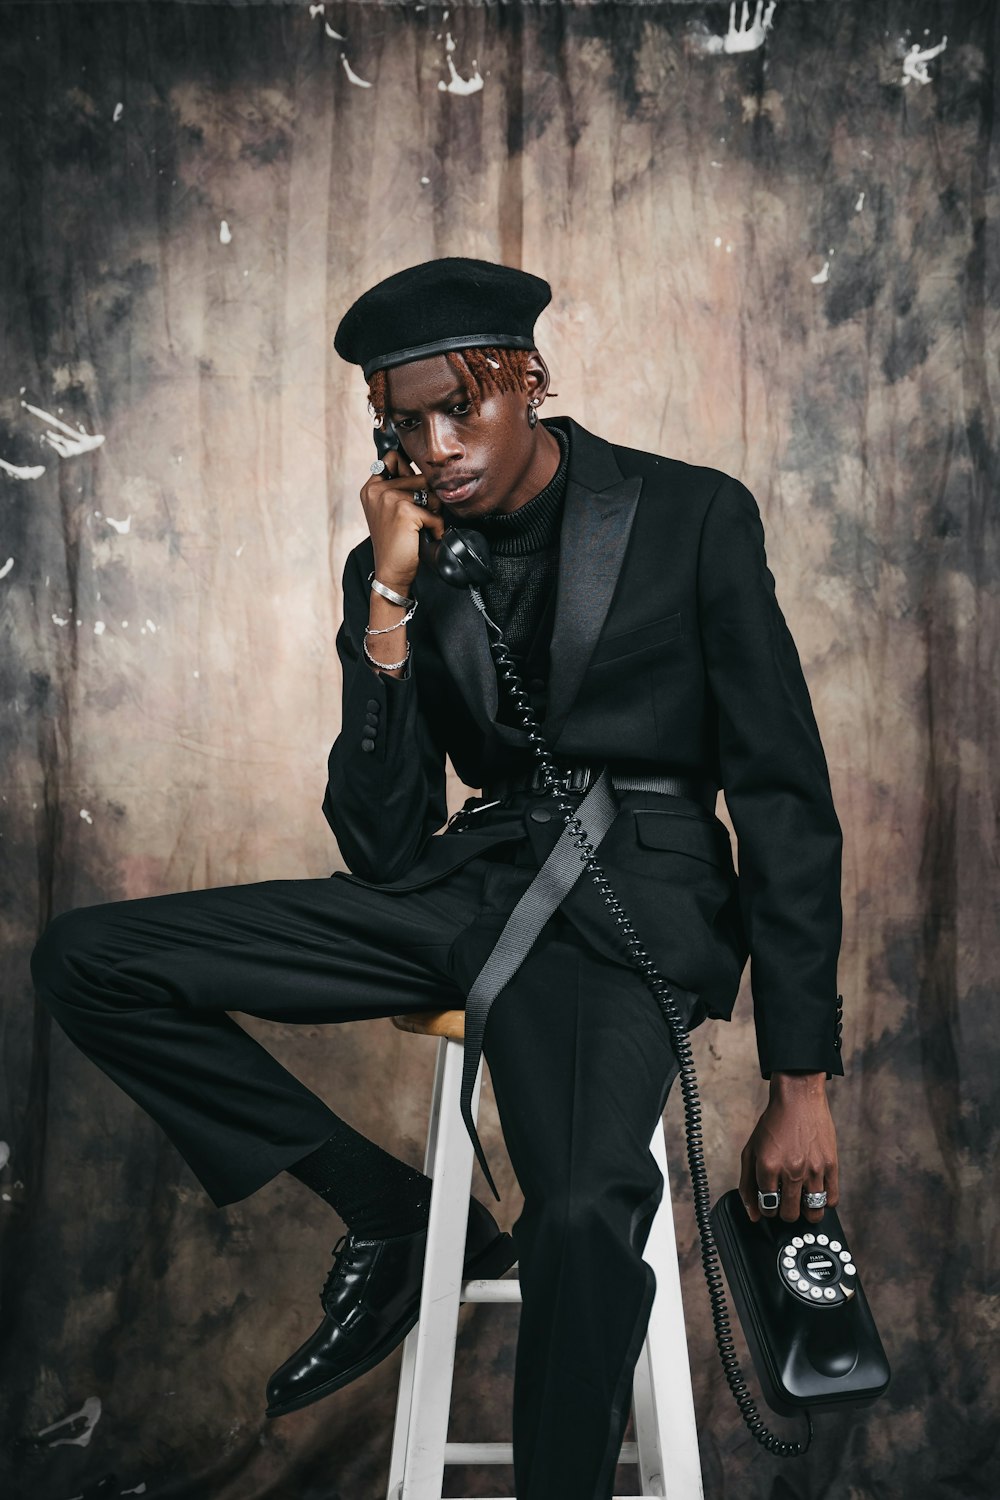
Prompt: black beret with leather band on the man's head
<box><xmin>333</xmin><ymin>255</ymin><xmax>552</xmax><ymax>380</ymax></box>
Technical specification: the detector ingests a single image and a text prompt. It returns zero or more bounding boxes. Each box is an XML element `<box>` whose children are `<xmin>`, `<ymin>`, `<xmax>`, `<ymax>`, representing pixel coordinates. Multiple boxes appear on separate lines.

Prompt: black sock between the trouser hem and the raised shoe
<box><xmin>288</xmin><ymin>1119</ymin><xmax>430</xmax><ymax>1239</ymax></box>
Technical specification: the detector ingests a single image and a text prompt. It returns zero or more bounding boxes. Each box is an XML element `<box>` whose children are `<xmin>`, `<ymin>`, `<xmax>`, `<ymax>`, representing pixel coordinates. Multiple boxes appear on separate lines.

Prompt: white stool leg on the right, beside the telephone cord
<box><xmin>633</xmin><ymin>1124</ymin><xmax>705</xmax><ymax>1500</ymax></box>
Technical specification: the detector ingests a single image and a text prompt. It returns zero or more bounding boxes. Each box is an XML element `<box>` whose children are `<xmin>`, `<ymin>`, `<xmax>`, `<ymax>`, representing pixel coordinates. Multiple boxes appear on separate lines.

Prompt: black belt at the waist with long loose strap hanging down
<box><xmin>459</xmin><ymin>767</ymin><xmax>704</xmax><ymax>1199</ymax></box>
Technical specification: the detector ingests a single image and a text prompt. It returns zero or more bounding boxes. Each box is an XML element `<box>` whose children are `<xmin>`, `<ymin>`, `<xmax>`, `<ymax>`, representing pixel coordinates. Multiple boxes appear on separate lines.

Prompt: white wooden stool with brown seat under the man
<box><xmin>387</xmin><ymin>1010</ymin><xmax>703</xmax><ymax>1500</ymax></box>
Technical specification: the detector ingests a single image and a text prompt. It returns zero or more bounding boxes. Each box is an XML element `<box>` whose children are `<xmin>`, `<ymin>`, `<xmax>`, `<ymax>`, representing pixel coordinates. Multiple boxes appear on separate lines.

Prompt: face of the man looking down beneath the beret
<box><xmin>385</xmin><ymin>354</ymin><xmax>542</xmax><ymax>524</ymax></box>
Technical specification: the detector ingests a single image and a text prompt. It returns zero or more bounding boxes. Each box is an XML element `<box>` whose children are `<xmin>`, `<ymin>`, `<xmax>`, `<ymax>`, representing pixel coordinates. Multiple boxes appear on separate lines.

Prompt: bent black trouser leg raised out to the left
<box><xmin>31</xmin><ymin>861</ymin><xmax>497</xmax><ymax>1205</ymax></box>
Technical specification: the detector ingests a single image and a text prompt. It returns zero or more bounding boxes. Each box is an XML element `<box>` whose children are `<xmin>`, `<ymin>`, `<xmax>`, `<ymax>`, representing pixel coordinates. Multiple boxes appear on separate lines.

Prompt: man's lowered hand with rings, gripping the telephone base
<box><xmin>739</xmin><ymin>1073</ymin><xmax>838</xmax><ymax>1224</ymax></box>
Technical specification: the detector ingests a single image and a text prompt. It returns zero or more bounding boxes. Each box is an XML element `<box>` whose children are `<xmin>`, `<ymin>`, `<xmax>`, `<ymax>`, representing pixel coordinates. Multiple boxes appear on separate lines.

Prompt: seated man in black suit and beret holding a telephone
<box><xmin>33</xmin><ymin>257</ymin><xmax>843</xmax><ymax>1500</ymax></box>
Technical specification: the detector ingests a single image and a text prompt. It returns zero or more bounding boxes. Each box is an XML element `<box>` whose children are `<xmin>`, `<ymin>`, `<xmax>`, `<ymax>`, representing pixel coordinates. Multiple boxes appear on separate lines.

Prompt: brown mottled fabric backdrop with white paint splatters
<box><xmin>0</xmin><ymin>0</ymin><xmax>1000</xmax><ymax>1500</ymax></box>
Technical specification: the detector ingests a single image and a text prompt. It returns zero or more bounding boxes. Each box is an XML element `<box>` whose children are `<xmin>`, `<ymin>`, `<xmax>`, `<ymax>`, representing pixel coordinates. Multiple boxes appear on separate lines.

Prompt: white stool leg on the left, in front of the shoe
<box><xmin>388</xmin><ymin>1037</ymin><xmax>483</xmax><ymax>1500</ymax></box>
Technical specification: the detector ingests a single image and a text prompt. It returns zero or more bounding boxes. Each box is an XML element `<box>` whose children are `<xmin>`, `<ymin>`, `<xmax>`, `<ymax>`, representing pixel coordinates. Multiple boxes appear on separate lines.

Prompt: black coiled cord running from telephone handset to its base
<box><xmin>469</xmin><ymin>585</ymin><xmax>813</xmax><ymax>1458</ymax></box>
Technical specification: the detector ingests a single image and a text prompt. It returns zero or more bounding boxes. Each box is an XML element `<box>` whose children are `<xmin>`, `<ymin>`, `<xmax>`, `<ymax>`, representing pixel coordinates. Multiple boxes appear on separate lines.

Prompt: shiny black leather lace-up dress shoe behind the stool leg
<box><xmin>267</xmin><ymin>1199</ymin><xmax>517</xmax><ymax>1416</ymax></box>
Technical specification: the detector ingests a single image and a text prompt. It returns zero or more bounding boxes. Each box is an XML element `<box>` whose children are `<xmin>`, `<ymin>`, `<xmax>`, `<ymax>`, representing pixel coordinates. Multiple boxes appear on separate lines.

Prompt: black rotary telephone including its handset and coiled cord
<box><xmin>375</xmin><ymin>417</ymin><xmax>891</xmax><ymax>1458</ymax></box>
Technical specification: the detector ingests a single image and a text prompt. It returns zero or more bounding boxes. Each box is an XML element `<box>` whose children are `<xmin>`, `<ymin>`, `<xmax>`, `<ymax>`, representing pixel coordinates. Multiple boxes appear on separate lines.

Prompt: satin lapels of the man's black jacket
<box><xmin>418</xmin><ymin>417</ymin><xmax>642</xmax><ymax>749</ymax></box>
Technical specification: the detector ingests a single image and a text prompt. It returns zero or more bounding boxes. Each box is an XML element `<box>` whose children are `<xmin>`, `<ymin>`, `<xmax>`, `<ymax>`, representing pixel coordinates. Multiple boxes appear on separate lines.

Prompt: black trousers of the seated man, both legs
<box><xmin>31</xmin><ymin>798</ymin><xmax>692</xmax><ymax>1500</ymax></box>
